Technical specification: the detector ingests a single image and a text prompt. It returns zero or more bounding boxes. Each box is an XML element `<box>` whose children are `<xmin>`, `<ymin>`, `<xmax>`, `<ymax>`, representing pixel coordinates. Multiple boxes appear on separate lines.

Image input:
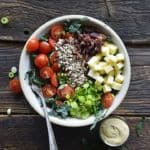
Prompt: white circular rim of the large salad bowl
<box><xmin>19</xmin><ymin>15</ymin><xmax>131</xmax><ymax>127</ymax></box>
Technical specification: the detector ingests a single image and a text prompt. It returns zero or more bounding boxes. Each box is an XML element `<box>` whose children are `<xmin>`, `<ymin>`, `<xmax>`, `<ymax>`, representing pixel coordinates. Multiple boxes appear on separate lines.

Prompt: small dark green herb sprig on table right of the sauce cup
<box><xmin>135</xmin><ymin>117</ymin><xmax>145</xmax><ymax>136</ymax></box>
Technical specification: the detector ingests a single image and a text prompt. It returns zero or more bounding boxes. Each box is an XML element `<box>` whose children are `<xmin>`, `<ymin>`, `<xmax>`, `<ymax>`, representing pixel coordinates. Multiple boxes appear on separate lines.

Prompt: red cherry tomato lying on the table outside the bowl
<box><xmin>9</xmin><ymin>79</ymin><xmax>21</xmax><ymax>94</ymax></box>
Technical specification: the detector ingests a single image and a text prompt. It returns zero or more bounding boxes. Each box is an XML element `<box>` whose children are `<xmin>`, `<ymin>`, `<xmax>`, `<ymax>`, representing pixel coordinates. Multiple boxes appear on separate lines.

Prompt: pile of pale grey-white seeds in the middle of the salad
<box><xmin>55</xmin><ymin>39</ymin><xmax>87</xmax><ymax>87</ymax></box>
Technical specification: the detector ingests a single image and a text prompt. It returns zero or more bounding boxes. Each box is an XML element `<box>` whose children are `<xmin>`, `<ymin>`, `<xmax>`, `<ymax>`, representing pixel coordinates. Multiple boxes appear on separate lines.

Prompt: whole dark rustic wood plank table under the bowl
<box><xmin>0</xmin><ymin>0</ymin><xmax>150</xmax><ymax>150</ymax></box>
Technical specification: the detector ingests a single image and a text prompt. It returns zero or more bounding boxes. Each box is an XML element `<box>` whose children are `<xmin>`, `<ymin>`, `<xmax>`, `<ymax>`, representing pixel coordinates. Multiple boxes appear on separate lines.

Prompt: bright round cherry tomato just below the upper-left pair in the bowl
<box><xmin>34</xmin><ymin>54</ymin><xmax>48</xmax><ymax>68</ymax></box>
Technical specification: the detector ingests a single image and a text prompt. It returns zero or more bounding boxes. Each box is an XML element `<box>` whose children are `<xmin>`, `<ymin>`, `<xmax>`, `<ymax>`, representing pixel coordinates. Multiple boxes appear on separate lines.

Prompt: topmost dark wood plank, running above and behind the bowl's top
<box><xmin>0</xmin><ymin>0</ymin><xmax>150</xmax><ymax>44</ymax></box>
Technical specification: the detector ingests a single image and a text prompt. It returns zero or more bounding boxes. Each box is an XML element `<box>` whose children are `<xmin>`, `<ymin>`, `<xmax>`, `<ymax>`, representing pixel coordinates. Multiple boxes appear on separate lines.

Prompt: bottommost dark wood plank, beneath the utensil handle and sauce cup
<box><xmin>0</xmin><ymin>116</ymin><xmax>150</xmax><ymax>150</ymax></box>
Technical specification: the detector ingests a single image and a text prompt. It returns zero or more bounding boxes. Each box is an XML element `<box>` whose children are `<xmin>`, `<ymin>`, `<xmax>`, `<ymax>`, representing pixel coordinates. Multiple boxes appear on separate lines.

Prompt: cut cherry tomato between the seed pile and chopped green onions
<box><xmin>57</xmin><ymin>85</ymin><xmax>74</xmax><ymax>99</ymax></box>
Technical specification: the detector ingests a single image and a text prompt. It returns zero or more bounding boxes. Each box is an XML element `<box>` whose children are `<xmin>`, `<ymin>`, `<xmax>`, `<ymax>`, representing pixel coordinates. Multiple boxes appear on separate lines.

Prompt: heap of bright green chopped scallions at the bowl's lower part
<box><xmin>66</xmin><ymin>83</ymin><xmax>102</xmax><ymax>119</ymax></box>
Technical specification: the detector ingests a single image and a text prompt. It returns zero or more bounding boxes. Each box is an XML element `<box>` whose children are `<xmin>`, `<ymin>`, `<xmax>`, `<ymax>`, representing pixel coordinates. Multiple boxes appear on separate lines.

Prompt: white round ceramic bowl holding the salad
<box><xmin>19</xmin><ymin>15</ymin><xmax>131</xmax><ymax>127</ymax></box>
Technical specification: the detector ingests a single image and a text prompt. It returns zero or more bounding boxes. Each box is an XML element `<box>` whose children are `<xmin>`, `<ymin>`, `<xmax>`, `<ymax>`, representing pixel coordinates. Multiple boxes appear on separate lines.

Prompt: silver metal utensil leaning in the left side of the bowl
<box><xmin>31</xmin><ymin>85</ymin><xmax>58</xmax><ymax>150</ymax></box>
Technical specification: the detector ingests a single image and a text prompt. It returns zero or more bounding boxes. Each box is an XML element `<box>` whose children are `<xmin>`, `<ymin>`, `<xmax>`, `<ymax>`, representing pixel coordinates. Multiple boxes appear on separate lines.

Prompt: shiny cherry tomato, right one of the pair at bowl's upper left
<box><xmin>39</xmin><ymin>41</ymin><xmax>52</xmax><ymax>54</ymax></box>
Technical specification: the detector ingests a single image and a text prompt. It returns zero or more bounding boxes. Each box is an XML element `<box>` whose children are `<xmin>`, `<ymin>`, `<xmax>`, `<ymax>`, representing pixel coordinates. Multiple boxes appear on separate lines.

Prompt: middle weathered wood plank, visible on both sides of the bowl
<box><xmin>0</xmin><ymin>42</ymin><xmax>150</xmax><ymax>115</ymax></box>
